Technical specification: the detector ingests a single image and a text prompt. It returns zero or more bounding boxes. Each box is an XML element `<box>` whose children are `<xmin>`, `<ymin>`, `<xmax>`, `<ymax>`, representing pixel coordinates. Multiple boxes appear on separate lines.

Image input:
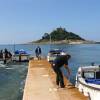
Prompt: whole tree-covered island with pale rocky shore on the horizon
<box><xmin>32</xmin><ymin>27</ymin><xmax>96</xmax><ymax>44</ymax></box>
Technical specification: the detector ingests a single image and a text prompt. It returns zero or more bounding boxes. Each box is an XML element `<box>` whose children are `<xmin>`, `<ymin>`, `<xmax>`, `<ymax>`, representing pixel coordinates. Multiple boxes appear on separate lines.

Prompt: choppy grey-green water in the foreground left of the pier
<box><xmin>0</xmin><ymin>65</ymin><xmax>27</xmax><ymax>100</ymax></box>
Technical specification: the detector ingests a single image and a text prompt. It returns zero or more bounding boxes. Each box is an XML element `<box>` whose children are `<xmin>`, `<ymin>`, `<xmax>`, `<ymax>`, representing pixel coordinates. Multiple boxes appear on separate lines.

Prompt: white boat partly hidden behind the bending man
<box><xmin>47</xmin><ymin>49</ymin><xmax>65</xmax><ymax>62</ymax></box>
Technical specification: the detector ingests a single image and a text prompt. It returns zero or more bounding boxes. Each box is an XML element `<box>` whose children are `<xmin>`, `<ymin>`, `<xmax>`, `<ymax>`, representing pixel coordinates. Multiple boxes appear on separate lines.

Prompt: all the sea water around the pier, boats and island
<box><xmin>0</xmin><ymin>44</ymin><xmax>100</xmax><ymax>100</ymax></box>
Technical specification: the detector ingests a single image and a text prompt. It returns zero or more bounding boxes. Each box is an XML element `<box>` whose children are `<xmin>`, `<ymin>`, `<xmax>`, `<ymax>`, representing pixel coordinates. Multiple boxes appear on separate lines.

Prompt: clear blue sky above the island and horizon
<box><xmin>0</xmin><ymin>0</ymin><xmax>100</xmax><ymax>44</ymax></box>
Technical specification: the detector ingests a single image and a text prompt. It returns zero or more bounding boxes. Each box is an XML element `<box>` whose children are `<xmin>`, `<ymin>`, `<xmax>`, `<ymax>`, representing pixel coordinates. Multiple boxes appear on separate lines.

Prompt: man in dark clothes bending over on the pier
<box><xmin>52</xmin><ymin>53</ymin><xmax>71</xmax><ymax>88</ymax></box>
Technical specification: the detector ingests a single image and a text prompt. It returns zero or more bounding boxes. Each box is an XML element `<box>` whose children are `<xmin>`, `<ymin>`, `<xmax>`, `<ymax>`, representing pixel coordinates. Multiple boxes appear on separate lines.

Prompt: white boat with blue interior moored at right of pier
<box><xmin>75</xmin><ymin>65</ymin><xmax>100</xmax><ymax>100</ymax></box>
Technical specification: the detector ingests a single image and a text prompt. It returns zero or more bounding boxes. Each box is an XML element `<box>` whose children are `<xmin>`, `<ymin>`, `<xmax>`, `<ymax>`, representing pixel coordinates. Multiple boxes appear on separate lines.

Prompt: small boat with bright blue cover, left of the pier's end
<box><xmin>12</xmin><ymin>49</ymin><xmax>30</xmax><ymax>62</ymax></box>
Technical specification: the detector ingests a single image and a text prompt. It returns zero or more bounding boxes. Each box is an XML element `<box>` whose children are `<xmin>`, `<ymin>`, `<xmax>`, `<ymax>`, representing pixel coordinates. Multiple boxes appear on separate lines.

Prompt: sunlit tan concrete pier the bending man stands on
<box><xmin>23</xmin><ymin>60</ymin><xmax>88</xmax><ymax>100</ymax></box>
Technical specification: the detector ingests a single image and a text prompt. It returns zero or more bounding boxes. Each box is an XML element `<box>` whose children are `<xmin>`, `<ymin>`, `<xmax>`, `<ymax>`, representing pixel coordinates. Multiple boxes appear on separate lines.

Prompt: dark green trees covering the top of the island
<box><xmin>40</xmin><ymin>27</ymin><xmax>84</xmax><ymax>41</ymax></box>
